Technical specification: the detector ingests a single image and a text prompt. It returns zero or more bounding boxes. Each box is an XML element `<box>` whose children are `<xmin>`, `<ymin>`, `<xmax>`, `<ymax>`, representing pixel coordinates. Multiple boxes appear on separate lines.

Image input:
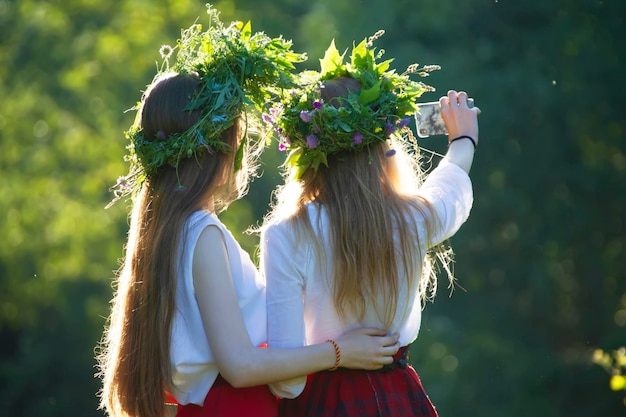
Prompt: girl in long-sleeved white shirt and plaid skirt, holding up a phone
<box><xmin>261</xmin><ymin>37</ymin><xmax>478</xmax><ymax>417</ymax></box>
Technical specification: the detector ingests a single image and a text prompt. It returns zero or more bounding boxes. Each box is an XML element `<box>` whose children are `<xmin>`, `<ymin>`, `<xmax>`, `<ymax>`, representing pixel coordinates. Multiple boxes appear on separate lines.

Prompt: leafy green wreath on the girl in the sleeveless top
<box><xmin>109</xmin><ymin>4</ymin><xmax>306</xmax><ymax>206</ymax></box>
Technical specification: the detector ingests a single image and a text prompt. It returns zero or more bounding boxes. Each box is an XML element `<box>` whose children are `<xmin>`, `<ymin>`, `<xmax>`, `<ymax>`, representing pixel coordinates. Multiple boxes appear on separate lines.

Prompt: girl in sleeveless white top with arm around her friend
<box><xmin>98</xmin><ymin>7</ymin><xmax>398</xmax><ymax>417</ymax></box>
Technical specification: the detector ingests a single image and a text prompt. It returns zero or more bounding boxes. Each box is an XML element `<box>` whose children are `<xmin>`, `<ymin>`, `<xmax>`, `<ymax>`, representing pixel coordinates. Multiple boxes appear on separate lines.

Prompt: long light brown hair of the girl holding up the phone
<box><xmin>266</xmin><ymin>77</ymin><xmax>449</xmax><ymax>326</ymax></box>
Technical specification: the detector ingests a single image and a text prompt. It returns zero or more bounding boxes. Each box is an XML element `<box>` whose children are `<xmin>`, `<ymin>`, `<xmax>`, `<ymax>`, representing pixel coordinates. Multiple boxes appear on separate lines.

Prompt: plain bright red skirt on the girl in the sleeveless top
<box><xmin>176</xmin><ymin>375</ymin><xmax>277</xmax><ymax>417</ymax></box>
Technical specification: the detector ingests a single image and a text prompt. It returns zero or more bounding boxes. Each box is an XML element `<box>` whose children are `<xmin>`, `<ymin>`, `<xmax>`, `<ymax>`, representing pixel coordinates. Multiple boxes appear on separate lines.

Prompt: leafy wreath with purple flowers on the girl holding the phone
<box><xmin>263</xmin><ymin>30</ymin><xmax>440</xmax><ymax>179</ymax></box>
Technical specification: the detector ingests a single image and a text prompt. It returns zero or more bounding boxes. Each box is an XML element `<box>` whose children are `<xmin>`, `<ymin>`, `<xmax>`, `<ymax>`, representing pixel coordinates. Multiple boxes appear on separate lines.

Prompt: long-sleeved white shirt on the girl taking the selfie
<box><xmin>261</xmin><ymin>160</ymin><xmax>473</xmax><ymax>398</ymax></box>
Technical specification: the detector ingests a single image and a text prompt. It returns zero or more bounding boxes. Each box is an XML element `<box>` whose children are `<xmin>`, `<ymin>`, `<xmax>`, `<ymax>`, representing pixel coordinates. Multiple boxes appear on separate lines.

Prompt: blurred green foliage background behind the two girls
<box><xmin>0</xmin><ymin>0</ymin><xmax>626</xmax><ymax>417</ymax></box>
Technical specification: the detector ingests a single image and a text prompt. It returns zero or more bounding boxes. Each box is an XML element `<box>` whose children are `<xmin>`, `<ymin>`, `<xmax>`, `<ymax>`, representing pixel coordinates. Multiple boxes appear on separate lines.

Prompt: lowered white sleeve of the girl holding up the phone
<box><xmin>261</xmin><ymin>223</ymin><xmax>306</xmax><ymax>398</ymax></box>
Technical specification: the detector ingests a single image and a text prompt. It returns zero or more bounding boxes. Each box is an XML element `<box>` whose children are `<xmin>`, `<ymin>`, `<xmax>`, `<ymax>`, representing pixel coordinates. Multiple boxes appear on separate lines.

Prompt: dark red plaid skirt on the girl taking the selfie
<box><xmin>278</xmin><ymin>347</ymin><xmax>437</xmax><ymax>417</ymax></box>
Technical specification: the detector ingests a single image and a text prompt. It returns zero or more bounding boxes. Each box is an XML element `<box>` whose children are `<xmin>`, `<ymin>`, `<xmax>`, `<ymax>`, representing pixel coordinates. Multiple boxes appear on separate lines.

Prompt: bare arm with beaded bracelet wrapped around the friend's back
<box><xmin>193</xmin><ymin>226</ymin><xmax>397</xmax><ymax>387</ymax></box>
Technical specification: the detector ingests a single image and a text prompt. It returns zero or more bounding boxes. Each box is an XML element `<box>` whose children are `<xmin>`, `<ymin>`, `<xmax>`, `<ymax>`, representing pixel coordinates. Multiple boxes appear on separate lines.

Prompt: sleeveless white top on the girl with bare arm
<box><xmin>170</xmin><ymin>211</ymin><xmax>267</xmax><ymax>405</ymax></box>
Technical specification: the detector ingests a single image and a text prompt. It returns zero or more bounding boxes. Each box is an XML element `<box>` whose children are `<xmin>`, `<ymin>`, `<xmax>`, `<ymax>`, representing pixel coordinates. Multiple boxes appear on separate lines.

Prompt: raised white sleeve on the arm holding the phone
<box><xmin>419</xmin><ymin>159</ymin><xmax>474</xmax><ymax>246</ymax></box>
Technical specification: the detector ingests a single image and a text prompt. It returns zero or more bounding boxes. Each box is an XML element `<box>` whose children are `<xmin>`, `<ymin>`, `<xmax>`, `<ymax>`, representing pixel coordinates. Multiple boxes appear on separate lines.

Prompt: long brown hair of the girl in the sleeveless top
<box><xmin>98</xmin><ymin>74</ymin><xmax>255</xmax><ymax>417</ymax></box>
